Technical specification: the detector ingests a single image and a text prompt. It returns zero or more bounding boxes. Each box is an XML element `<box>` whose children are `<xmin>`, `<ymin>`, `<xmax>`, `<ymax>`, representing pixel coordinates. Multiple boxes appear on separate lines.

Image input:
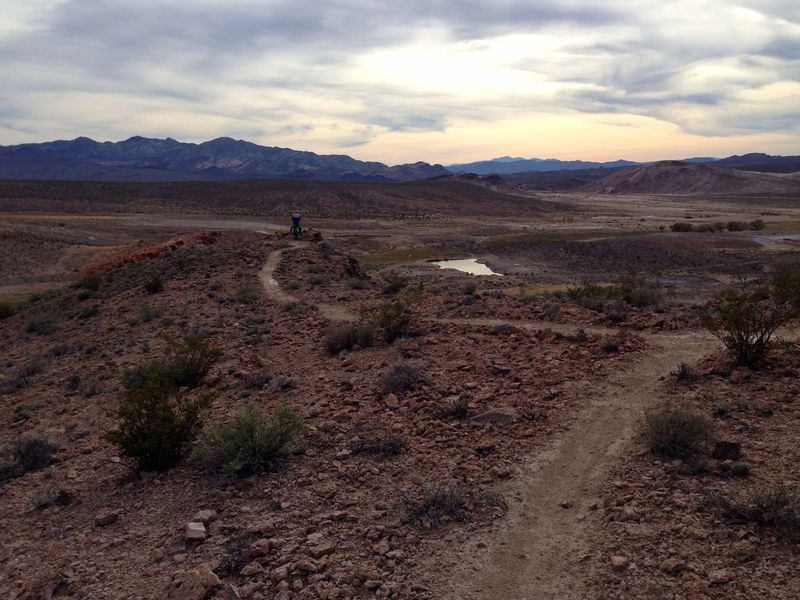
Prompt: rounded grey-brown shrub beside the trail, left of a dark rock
<box><xmin>644</xmin><ymin>408</ymin><xmax>712</xmax><ymax>459</ymax></box>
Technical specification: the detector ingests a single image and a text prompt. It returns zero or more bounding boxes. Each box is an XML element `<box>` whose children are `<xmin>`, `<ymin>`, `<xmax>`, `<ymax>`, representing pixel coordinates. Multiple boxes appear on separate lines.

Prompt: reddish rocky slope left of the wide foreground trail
<box><xmin>0</xmin><ymin>234</ymin><xmax>646</xmax><ymax>599</ymax></box>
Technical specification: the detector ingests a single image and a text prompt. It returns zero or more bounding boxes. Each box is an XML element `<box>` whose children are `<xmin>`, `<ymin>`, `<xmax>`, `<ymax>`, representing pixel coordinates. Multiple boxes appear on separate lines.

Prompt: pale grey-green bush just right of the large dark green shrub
<box><xmin>194</xmin><ymin>406</ymin><xmax>305</xmax><ymax>477</ymax></box>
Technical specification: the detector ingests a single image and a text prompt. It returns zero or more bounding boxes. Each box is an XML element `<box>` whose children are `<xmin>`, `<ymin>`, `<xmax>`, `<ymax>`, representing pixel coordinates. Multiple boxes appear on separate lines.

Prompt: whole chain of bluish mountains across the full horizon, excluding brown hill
<box><xmin>0</xmin><ymin>136</ymin><xmax>800</xmax><ymax>182</ymax></box>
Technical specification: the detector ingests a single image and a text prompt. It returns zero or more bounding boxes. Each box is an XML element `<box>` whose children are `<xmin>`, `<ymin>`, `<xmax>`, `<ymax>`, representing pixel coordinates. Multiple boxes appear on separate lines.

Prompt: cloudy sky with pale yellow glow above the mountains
<box><xmin>0</xmin><ymin>0</ymin><xmax>800</xmax><ymax>164</ymax></box>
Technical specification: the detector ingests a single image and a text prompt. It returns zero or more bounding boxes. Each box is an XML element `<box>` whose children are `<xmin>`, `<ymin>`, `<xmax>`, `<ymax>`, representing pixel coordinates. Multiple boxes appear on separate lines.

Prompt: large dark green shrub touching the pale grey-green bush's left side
<box><xmin>105</xmin><ymin>381</ymin><xmax>212</xmax><ymax>471</ymax></box>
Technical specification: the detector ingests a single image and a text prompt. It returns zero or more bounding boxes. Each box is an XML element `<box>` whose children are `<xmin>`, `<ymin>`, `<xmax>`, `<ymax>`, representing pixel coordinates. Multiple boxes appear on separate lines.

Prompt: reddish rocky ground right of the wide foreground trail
<box><xmin>580</xmin><ymin>343</ymin><xmax>800</xmax><ymax>600</ymax></box>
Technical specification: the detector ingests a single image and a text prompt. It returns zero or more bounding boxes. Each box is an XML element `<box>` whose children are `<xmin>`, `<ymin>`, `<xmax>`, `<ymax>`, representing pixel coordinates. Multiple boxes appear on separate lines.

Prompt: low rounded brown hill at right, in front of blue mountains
<box><xmin>582</xmin><ymin>160</ymin><xmax>800</xmax><ymax>195</ymax></box>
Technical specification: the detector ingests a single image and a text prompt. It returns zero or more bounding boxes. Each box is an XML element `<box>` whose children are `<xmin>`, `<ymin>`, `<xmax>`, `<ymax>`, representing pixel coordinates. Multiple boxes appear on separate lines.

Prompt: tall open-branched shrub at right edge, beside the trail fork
<box><xmin>703</xmin><ymin>270</ymin><xmax>800</xmax><ymax>368</ymax></box>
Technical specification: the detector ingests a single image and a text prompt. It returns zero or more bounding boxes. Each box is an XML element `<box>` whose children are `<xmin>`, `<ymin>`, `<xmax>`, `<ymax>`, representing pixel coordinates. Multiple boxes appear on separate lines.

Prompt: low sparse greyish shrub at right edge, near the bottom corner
<box><xmin>712</xmin><ymin>484</ymin><xmax>800</xmax><ymax>542</ymax></box>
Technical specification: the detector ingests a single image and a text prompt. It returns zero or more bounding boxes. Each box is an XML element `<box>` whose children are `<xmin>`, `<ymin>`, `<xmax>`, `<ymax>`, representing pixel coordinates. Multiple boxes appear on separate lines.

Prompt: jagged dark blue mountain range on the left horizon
<box><xmin>0</xmin><ymin>136</ymin><xmax>448</xmax><ymax>182</ymax></box>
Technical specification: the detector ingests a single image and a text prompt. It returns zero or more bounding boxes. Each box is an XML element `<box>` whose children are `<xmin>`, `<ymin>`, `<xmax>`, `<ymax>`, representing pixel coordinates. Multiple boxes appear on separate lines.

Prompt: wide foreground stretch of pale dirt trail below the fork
<box><xmin>444</xmin><ymin>332</ymin><xmax>715</xmax><ymax>600</ymax></box>
